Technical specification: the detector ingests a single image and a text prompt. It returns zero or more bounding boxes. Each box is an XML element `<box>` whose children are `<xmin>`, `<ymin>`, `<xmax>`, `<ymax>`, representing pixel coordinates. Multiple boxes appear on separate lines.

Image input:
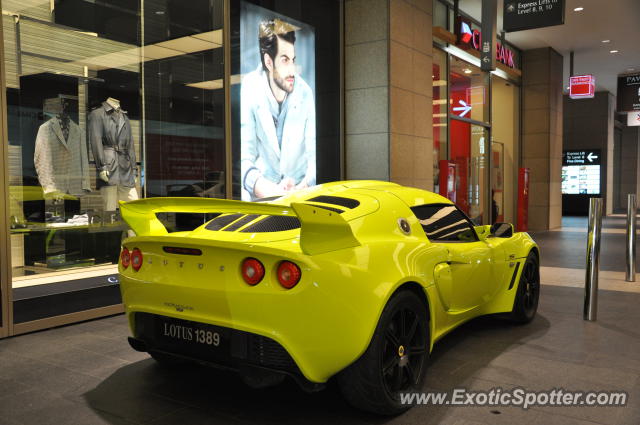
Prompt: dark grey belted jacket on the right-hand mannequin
<box><xmin>88</xmin><ymin>102</ymin><xmax>136</xmax><ymax>188</ymax></box>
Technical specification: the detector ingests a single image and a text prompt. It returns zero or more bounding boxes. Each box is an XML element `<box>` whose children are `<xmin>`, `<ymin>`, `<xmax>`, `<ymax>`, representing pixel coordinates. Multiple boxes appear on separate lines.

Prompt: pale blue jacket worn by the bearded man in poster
<box><xmin>240</xmin><ymin>65</ymin><xmax>316</xmax><ymax>200</ymax></box>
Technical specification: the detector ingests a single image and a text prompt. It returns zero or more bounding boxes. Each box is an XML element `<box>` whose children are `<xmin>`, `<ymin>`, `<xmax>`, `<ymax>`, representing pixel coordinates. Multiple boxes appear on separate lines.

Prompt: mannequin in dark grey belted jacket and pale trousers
<box><xmin>88</xmin><ymin>97</ymin><xmax>138</xmax><ymax>211</ymax></box>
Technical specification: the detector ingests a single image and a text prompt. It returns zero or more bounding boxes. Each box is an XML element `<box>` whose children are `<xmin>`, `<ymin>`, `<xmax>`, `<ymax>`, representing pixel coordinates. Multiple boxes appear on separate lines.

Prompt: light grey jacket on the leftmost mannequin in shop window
<box><xmin>33</xmin><ymin>118</ymin><xmax>91</xmax><ymax>195</ymax></box>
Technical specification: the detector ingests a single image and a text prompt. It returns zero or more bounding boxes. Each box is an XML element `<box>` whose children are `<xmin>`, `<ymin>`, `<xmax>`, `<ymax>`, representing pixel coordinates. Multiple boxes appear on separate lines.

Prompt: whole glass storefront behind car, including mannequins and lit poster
<box><xmin>0</xmin><ymin>0</ymin><xmax>342</xmax><ymax>329</ymax></box>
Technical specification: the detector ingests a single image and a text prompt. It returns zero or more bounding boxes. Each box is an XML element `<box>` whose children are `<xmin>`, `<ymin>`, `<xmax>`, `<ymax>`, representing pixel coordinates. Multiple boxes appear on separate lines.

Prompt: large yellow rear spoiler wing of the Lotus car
<box><xmin>120</xmin><ymin>198</ymin><xmax>360</xmax><ymax>255</ymax></box>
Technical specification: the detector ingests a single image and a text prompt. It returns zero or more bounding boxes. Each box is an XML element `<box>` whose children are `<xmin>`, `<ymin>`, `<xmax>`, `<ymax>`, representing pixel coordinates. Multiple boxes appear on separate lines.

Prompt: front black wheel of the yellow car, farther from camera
<box><xmin>510</xmin><ymin>252</ymin><xmax>540</xmax><ymax>324</ymax></box>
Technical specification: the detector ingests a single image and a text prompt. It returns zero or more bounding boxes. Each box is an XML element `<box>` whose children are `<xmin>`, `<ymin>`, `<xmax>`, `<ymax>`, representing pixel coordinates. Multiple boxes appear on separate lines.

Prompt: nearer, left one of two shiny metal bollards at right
<box><xmin>583</xmin><ymin>198</ymin><xmax>602</xmax><ymax>321</ymax></box>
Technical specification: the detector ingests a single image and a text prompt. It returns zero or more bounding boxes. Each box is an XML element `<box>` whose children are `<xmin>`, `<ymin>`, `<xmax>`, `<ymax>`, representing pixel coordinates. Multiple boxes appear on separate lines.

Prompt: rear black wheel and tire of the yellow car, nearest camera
<box><xmin>338</xmin><ymin>290</ymin><xmax>430</xmax><ymax>415</ymax></box>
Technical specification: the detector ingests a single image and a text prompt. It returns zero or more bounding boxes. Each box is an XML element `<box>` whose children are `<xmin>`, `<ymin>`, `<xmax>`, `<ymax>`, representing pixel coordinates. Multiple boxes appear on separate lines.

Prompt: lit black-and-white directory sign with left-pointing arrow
<box><xmin>562</xmin><ymin>149</ymin><xmax>601</xmax><ymax>195</ymax></box>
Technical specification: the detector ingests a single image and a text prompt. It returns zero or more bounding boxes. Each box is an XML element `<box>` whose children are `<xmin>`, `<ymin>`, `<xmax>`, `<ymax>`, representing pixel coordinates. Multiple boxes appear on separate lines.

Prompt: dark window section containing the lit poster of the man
<box><xmin>231</xmin><ymin>0</ymin><xmax>341</xmax><ymax>201</ymax></box>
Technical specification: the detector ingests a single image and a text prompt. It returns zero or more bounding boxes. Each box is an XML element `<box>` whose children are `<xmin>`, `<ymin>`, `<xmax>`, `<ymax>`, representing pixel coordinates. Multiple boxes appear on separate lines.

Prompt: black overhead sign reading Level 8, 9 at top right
<box><xmin>502</xmin><ymin>0</ymin><xmax>565</xmax><ymax>32</ymax></box>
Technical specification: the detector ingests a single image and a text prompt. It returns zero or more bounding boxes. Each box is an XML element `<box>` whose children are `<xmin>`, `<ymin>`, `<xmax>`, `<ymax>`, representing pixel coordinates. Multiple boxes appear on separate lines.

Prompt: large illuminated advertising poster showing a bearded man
<box><xmin>240</xmin><ymin>2</ymin><xmax>316</xmax><ymax>201</ymax></box>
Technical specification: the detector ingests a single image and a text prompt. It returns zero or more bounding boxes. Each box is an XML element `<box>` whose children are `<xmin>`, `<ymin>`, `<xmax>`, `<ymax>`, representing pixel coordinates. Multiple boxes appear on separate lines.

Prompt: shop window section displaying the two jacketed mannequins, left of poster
<box><xmin>1</xmin><ymin>0</ymin><xmax>227</xmax><ymax>323</ymax></box>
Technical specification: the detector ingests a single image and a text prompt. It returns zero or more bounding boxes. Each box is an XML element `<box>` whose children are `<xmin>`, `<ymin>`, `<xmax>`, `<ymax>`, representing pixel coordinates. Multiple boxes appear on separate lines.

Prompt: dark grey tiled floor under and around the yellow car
<box><xmin>0</xmin><ymin>286</ymin><xmax>640</xmax><ymax>425</ymax></box>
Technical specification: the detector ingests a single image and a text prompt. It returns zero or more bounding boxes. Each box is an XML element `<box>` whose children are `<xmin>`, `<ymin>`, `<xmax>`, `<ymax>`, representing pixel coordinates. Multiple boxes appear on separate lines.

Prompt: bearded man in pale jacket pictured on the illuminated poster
<box><xmin>240</xmin><ymin>19</ymin><xmax>316</xmax><ymax>200</ymax></box>
